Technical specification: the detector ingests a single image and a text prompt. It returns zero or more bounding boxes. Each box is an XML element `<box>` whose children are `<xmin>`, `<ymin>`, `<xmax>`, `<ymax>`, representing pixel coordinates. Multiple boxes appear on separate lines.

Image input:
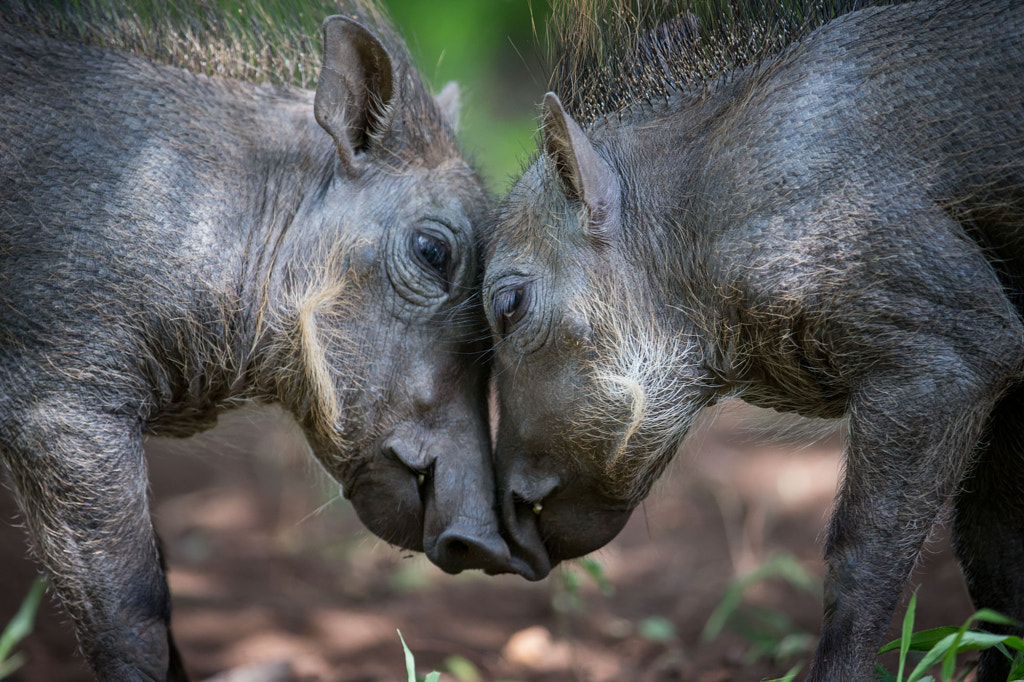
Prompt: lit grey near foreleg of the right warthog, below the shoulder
<box><xmin>808</xmin><ymin>365</ymin><xmax>998</xmax><ymax>682</ymax></box>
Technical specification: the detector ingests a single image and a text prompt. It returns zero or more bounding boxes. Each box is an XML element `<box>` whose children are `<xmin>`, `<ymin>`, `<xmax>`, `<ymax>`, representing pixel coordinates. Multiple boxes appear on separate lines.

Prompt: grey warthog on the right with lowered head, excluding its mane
<box><xmin>483</xmin><ymin>0</ymin><xmax>1024</xmax><ymax>682</ymax></box>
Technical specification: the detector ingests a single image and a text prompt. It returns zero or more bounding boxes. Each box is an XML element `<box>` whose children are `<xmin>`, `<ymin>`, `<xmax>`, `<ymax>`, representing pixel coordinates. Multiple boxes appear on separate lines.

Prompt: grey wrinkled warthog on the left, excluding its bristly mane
<box><xmin>0</xmin><ymin>17</ymin><xmax>508</xmax><ymax>681</ymax></box>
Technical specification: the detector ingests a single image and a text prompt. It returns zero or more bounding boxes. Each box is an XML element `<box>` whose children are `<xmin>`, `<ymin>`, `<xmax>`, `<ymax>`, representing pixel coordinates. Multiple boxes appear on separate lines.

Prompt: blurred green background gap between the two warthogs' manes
<box><xmin>383</xmin><ymin>0</ymin><xmax>550</xmax><ymax>193</ymax></box>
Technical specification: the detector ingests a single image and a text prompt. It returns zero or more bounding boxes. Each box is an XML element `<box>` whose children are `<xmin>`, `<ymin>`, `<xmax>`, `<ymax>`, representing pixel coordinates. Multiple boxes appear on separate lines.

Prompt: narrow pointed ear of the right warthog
<box><xmin>541</xmin><ymin>92</ymin><xmax>621</xmax><ymax>243</ymax></box>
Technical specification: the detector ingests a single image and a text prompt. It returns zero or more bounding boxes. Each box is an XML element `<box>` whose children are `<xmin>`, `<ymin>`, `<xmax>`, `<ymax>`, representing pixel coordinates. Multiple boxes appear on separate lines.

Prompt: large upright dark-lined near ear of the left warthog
<box><xmin>313</xmin><ymin>15</ymin><xmax>394</xmax><ymax>173</ymax></box>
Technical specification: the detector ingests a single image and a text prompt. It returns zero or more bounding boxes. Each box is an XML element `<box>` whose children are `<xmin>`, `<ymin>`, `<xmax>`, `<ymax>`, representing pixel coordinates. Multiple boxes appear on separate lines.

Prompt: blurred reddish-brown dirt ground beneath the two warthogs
<box><xmin>0</xmin><ymin>403</ymin><xmax>971</xmax><ymax>682</ymax></box>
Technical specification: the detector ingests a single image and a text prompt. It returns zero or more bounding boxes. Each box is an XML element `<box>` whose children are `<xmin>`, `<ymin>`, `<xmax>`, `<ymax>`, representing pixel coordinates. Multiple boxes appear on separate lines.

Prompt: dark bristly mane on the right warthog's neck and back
<box><xmin>547</xmin><ymin>0</ymin><xmax>892</xmax><ymax>125</ymax></box>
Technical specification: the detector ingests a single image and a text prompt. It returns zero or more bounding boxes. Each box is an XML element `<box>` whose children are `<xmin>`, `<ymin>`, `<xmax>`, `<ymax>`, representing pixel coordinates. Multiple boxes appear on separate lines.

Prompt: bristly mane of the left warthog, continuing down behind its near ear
<box><xmin>0</xmin><ymin>0</ymin><xmax>459</xmax><ymax>167</ymax></box>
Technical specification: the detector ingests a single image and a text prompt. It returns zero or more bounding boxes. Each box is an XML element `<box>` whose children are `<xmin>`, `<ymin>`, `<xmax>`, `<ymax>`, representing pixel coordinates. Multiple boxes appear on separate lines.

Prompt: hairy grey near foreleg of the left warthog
<box><xmin>0</xmin><ymin>396</ymin><xmax>186</xmax><ymax>682</ymax></box>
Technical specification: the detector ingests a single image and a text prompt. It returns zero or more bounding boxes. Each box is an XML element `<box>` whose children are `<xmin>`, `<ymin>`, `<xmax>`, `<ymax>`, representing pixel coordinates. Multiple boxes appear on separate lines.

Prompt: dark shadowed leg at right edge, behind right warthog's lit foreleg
<box><xmin>953</xmin><ymin>389</ymin><xmax>1024</xmax><ymax>682</ymax></box>
